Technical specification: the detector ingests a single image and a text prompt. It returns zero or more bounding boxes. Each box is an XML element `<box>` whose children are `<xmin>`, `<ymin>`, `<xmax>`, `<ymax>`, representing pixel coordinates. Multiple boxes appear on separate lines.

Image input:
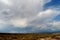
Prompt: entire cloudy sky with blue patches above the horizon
<box><xmin>0</xmin><ymin>0</ymin><xmax>60</xmax><ymax>33</ymax></box>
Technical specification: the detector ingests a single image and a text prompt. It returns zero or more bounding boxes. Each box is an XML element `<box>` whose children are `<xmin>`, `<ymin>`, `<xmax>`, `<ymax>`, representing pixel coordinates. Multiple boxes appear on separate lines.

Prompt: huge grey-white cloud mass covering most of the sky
<box><xmin>0</xmin><ymin>0</ymin><xmax>60</xmax><ymax>32</ymax></box>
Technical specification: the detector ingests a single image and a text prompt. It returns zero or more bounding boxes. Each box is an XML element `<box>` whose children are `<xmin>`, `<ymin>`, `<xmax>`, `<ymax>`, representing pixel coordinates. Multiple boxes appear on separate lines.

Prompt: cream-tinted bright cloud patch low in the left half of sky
<box><xmin>10</xmin><ymin>19</ymin><xmax>27</xmax><ymax>28</ymax></box>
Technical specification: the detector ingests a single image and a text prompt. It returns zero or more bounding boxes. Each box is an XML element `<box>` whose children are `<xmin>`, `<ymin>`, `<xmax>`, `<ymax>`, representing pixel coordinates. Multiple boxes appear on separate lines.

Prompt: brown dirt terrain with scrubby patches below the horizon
<box><xmin>0</xmin><ymin>33</ymin><xmax>60</xmax><ymax>40</ymax></box>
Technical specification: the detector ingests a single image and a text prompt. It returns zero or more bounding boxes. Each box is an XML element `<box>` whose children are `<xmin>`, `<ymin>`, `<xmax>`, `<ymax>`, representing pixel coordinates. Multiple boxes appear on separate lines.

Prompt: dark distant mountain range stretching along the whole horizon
<box><xmin>0</xmin><ymin>30</ymin><xmax>60</xmax><ymax>34</ymax></box>
